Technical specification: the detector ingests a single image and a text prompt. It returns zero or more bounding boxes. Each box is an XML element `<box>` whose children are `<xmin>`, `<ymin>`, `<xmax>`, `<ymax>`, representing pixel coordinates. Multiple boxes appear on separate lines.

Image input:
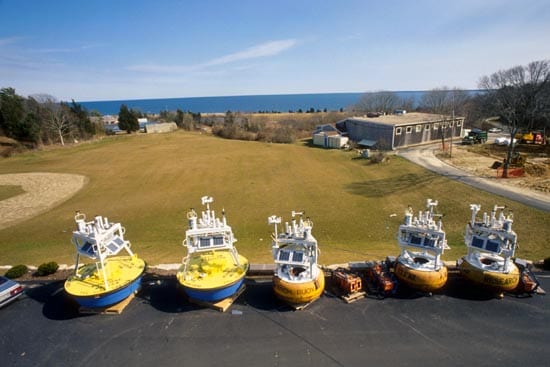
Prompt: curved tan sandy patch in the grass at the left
<box><xmin>0</xmin><ymin>172</ymin><xmax>87</xmax><ymax>230</ymax></box>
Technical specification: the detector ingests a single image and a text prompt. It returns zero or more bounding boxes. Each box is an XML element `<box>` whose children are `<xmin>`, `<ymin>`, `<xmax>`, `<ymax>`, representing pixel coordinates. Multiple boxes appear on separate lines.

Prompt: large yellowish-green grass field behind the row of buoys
<box><xmin>0</xmin><ymin>132</ymin><xmax>550</xmax><ymax>265</ymax></box>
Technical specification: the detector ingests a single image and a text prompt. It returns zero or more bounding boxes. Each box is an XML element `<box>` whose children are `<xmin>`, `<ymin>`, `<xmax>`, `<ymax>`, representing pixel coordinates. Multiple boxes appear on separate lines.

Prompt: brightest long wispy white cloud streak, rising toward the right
<box><xmin>127</xmin><ymin>39</ymin><xmax>298</xmax><ymax>73</ymax></box>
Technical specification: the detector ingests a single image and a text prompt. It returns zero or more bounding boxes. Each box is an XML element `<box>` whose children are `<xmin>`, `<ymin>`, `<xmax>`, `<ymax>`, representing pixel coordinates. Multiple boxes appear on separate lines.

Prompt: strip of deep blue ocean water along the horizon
<box><xmin>79</xmin><ymin>91</ymin><xmax>432</xmax><ymax>115</ymax></box>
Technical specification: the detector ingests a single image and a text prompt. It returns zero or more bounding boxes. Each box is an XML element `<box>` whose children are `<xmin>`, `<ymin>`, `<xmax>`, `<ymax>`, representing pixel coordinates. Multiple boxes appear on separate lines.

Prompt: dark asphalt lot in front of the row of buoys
<box><xmin>0</xmin><ymin>273</ymin><xmax>550</xmax><ymax>367</ymax></box>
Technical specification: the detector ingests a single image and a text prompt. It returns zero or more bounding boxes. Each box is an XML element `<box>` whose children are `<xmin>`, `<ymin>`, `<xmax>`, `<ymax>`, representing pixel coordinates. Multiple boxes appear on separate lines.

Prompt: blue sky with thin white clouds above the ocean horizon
<box><xmin>0</xmin><ymin>0</ymin><xmax>550</xmax><ymax>101</ymax></box>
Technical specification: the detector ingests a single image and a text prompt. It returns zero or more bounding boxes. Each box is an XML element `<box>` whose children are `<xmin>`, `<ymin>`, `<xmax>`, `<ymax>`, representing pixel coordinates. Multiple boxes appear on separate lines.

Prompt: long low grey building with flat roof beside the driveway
<box><xmin>336</xmin><ymin>112</ymin><xmax>464</xmax><ymax>150</ymax></box>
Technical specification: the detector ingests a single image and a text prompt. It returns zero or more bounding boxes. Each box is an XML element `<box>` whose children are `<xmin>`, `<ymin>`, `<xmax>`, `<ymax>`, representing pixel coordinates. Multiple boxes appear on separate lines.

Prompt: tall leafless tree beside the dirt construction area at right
<box><xmin>479</xmin><ymin>60</ymin><xmax>550</xmax><ymax>177</ymax></box>
